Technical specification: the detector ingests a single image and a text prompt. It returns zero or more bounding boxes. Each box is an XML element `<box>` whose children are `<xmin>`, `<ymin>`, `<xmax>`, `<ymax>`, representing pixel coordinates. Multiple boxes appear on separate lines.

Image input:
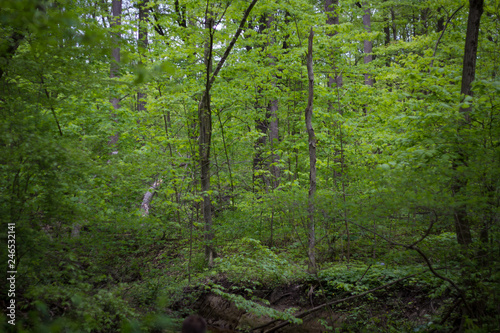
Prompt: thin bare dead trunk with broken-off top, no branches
<box><xmin>305</xmin><ymin>27</ymin><xmax>316</xmax><ymax>273</ymax></box>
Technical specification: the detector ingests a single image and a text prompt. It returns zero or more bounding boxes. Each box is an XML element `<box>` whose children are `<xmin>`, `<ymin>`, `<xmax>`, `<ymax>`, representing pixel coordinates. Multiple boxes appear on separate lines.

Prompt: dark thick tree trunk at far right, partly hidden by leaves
<box><xmin>452</xmin><ymin>0</ymin><xmax>484</xmax><ymax>245</ymax></box>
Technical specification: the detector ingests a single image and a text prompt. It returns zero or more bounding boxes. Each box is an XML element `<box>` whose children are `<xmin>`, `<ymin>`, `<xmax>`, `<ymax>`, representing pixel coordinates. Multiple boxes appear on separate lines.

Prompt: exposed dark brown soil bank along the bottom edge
<box><xmin>176</xmin><ymin>281</ymin><xmax>442</xmax><ymax>333</ymax></box>
